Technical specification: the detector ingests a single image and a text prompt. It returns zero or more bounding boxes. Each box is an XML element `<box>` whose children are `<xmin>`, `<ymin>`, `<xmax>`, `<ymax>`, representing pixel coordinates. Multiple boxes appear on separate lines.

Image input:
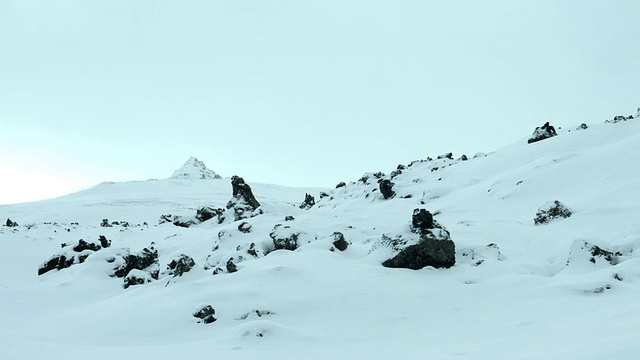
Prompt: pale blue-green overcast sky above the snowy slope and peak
<box><xmin>0</xmin><ymin>0</ymin><xmax>640</xmax><ymax>204</ymax></box>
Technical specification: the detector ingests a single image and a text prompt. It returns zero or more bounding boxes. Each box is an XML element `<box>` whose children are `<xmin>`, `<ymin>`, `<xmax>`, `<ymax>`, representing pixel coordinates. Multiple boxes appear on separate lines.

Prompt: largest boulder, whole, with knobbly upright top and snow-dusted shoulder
<box><xmin>382</xmin><ymin>209</ymin><xmax>456</xmax><ymax>270</ymax></box>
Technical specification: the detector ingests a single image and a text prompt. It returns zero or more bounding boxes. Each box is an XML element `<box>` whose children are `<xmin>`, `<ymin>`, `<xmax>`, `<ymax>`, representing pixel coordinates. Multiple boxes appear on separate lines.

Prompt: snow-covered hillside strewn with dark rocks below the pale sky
<box><xmin>0</xmin><ymin>120</ymin><xmax>640</xmax><ymax>360</ymax></box>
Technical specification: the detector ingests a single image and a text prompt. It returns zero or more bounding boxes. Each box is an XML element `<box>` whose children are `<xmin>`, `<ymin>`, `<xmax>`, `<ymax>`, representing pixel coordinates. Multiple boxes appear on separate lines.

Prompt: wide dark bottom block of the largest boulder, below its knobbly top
<box><xmin>382</xmin><ymin>237</ymin><xmax>456</xmax><ymax>270</ymax></box>
